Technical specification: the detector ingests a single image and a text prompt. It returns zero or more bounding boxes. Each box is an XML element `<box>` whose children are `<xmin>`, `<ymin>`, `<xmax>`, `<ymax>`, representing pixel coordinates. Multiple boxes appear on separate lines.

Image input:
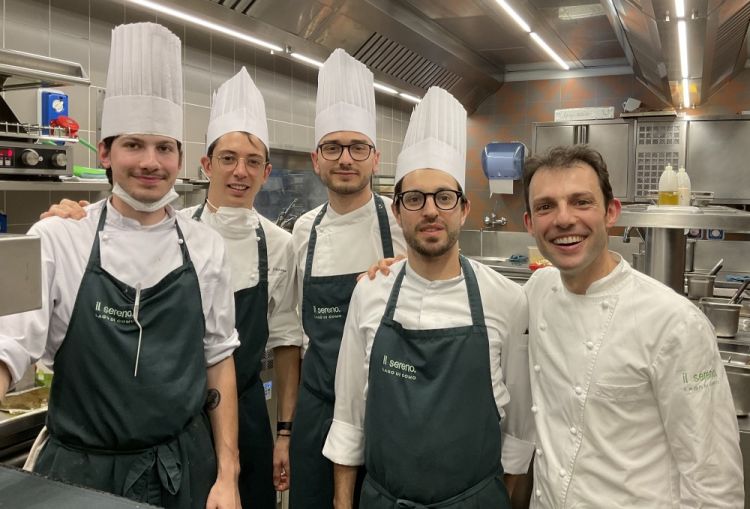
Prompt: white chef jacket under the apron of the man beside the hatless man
<box><xmin>323</xmin><ymin>260</ymin><xmax>534</xmax><ymax>474</ymax></box>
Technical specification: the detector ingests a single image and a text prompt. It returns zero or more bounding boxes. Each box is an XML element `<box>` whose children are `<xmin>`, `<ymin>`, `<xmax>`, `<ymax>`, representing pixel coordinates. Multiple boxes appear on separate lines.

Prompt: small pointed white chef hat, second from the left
<box><xmin>206</xmin><ymin>67</ymin><xmax>269</xmax><ymax>155</ymax></box>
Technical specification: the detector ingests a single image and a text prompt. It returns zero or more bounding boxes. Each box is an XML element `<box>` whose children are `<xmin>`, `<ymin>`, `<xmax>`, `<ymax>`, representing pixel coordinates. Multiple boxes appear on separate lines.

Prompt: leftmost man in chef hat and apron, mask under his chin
<box><xmin>0</xmin><ymin>23</ymin><xmax>239</xmax><ymax>508</ymax></box>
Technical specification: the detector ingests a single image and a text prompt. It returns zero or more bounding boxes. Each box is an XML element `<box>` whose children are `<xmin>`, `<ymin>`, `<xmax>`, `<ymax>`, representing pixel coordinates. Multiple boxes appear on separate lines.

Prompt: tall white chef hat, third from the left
<box><xmin>315</xmin><ymin>48</ymin><xmax>375</xmax><ymax>145</ymax></box>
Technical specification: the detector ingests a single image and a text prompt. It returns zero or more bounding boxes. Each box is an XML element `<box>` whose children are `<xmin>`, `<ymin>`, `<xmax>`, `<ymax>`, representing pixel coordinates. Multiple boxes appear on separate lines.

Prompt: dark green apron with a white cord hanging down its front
<box><xmin>35</xmin><ymin>202</ymin><xmax>216</xmax><ymax>509</ymax></box>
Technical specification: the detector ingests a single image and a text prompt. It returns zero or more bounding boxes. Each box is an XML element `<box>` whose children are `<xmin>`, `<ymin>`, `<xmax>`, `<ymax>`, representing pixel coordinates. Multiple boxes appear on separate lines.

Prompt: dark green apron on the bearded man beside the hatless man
<box><xmin>359</xmin><ymin>256</ymin><xmax>510</xmax><ymax>509</ymax></box>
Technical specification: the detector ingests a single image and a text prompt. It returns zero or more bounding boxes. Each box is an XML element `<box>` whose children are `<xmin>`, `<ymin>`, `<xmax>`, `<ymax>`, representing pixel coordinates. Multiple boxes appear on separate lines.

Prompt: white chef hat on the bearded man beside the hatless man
<box><xmin>395</xmin><ymin>87</ymin><xmax>466</xmax><ymax>190</ymax></box>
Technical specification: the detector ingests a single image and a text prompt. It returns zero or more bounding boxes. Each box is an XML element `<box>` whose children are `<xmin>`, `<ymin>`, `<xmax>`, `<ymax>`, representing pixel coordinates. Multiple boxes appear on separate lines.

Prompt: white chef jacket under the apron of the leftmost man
<box><xmin>0</xmin><ymin>200</ymin><xmax>240</xmax><ymax>383</ymax></box>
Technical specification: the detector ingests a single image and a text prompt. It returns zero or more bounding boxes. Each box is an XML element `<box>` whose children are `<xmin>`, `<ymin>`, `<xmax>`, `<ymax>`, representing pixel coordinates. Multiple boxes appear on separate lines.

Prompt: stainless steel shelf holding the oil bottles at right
<box><xmin>615</xmin><ymin>204</ymin><xmax>750</xmax><ymax>233</ymax></box>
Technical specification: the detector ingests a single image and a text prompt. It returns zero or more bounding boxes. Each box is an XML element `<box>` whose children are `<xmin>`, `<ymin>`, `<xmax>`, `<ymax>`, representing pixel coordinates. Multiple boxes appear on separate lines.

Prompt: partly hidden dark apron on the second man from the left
<box><xmin>193</xmin><ymin>203</ymin><xmax>276</xmax><ymax>509</ymax></box>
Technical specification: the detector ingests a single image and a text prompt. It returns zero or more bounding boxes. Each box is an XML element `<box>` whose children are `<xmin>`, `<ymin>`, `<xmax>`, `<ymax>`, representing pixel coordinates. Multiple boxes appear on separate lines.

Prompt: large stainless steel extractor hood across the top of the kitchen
<box><xmin>117</xmin><ymin>0</ymin><xmax>750</xmax><ymax>113</ymax></box>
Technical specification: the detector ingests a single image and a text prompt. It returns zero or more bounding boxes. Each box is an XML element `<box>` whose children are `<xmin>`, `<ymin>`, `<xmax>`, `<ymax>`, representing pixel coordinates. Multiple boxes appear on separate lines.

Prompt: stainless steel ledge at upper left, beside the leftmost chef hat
<box><xmin>0</xmin><ymin>49</ymin><xmax>90</xmax><ymax>90</ymax></box>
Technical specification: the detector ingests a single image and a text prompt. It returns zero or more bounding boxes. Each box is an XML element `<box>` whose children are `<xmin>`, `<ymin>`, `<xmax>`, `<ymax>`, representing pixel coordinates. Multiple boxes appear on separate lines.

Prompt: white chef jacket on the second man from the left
<box><xmin>184</xmin><ymin>205</ymin><xmax>302</xmax><ymax>349</ymax></box>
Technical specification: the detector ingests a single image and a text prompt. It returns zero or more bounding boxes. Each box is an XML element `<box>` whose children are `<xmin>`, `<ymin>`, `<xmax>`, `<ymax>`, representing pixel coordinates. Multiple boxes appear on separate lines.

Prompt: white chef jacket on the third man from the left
<box><xmin>292</xmin><ymin>196</ymin><xmax>406</xmax><ymax>354</ymax></box>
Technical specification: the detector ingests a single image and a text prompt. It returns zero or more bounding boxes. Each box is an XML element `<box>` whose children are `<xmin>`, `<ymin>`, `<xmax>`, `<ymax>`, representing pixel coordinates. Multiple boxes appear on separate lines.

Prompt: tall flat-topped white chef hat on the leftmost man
<box><xmin>101</xmin><ymin>23</ymin><xmax>182</xmax><ymax>141</ymax></box>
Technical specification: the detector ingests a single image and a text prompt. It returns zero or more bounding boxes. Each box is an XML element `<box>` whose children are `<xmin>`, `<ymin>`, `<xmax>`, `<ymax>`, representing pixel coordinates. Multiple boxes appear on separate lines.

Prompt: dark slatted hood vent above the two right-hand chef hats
<box><xmin>353</xmin><ymin>32</ymin><xmax>461</xmax><ymax>91</ymax></box>
